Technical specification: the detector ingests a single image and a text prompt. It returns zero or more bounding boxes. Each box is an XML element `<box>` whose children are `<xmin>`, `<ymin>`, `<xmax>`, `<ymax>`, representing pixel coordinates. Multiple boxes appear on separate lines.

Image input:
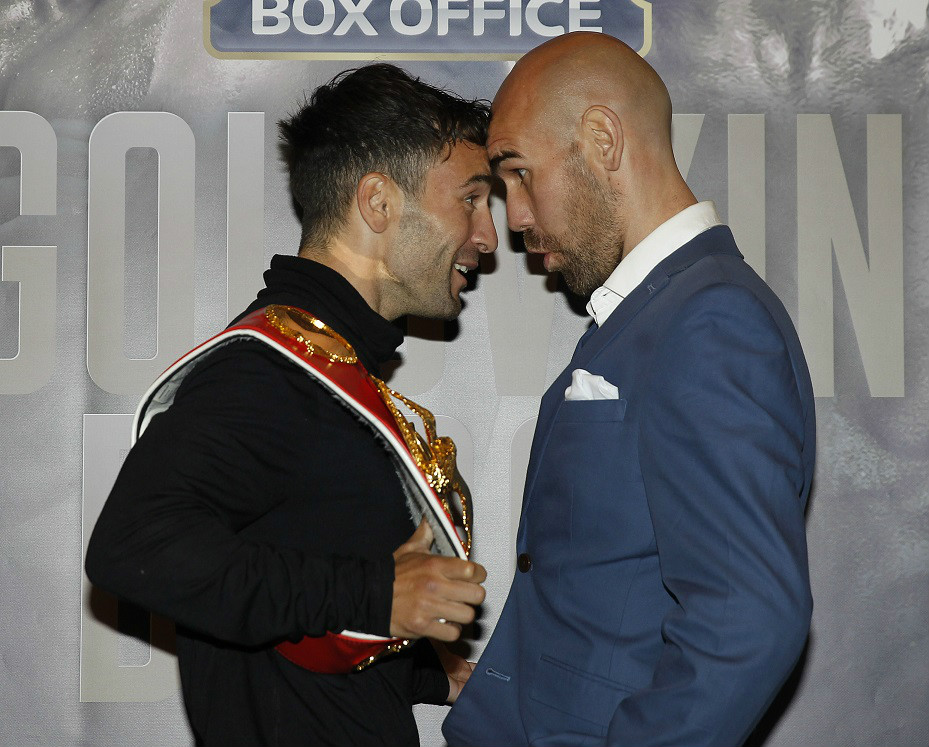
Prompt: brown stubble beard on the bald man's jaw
<box><xmin>523</xmin><ymin>150</ymin><xmax>625</xmax><ymax>296</ymax></box>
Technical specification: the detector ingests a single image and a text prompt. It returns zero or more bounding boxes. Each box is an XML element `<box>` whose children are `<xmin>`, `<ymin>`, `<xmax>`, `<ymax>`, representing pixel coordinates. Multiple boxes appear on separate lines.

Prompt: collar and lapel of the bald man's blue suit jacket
<box><xmin>523</xmin><ymin>226</ymin><xmax>742</xmax><ymax>510</ymax></box>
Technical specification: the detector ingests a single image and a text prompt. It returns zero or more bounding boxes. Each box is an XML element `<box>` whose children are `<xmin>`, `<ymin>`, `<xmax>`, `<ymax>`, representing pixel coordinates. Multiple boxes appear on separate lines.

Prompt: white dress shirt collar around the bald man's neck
<box><xmin>587</xmin><ymin>201</ymin><xmax>722</xmax><ymax>327</ymax></box>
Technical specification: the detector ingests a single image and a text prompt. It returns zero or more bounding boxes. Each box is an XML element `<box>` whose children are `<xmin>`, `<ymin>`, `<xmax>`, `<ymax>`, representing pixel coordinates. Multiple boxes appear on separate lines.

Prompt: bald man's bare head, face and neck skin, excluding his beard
<box><xmin>487</xmin><ymin>32</ymin><xmax>696</xmax><ymax>264</ymax></box>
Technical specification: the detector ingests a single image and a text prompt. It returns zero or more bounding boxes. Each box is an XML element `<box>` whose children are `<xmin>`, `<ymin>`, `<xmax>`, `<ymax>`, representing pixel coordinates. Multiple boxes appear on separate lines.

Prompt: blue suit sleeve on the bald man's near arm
<box><xmin>608</xmin><ymin>285</ymin><xmax>812</xmax><ymax>747</ymax></box>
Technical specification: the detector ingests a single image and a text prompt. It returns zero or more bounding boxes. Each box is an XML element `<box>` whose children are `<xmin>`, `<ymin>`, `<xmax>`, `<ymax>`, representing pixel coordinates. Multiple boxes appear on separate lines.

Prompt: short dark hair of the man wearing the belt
<box><xmin>278</xmin><ymin>63</ymin><xmax>490</xmax><ymax>249</ymax></box>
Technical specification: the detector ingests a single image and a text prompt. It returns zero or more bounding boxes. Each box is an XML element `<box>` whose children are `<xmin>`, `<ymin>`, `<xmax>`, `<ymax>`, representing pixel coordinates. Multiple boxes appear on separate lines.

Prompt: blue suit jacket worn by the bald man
<box><xmin>443</xmin><ymin>226</ymin><xmax>815</xmax><ymax>747</ymax></box>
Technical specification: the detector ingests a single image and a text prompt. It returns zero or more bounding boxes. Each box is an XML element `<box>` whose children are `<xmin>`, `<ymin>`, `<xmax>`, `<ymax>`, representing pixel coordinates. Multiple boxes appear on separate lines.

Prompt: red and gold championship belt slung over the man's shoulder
<box><xmin>132</xmin><ymin>306</ymin><xmax>471</xmax><ymax>674</ymax></box>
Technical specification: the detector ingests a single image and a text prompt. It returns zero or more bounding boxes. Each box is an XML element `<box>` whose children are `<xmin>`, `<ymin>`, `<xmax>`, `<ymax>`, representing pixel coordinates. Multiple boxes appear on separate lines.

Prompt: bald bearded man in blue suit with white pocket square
<box><xmin>443</xmin><ymin>33</ymin><xmax>815</xmax><ymax>747</ymax></box>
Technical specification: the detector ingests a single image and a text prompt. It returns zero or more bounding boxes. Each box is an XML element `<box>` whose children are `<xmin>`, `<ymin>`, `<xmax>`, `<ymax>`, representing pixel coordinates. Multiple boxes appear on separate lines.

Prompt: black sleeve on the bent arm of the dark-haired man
<box><xmin>86</xmin><ymin>344</ymin><xmax>393</xmax><ymax>645</ymax></box>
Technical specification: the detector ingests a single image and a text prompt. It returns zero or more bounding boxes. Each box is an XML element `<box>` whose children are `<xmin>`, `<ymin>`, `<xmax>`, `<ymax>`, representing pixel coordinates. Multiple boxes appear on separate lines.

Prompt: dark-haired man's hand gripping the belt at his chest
<box><xmin>390</xmin><ymin>519</ymin><xmax>487</xmax><ymax>641</ymax></box>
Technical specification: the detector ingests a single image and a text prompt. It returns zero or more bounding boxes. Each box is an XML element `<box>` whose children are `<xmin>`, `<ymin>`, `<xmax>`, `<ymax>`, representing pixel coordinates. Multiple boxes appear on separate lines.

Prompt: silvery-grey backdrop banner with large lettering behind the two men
<box><xmin>0</xmin><ymin>0</ymin><xmax>929</xmax><ymax>747</ymax></box>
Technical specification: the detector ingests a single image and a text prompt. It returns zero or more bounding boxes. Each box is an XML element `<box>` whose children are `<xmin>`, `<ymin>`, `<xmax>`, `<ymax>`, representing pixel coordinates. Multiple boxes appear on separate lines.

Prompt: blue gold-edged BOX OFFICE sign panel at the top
<box><xmin>204</xmin><ymin>0</ymin><xmax>652</xmax><ymax>60</ymax></box>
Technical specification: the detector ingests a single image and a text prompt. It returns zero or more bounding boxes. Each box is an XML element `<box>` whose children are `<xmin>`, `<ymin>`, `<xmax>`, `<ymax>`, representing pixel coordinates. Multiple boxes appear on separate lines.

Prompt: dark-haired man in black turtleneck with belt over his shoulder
<box><xmin>86</xmin><ymin>65</ymin><xmax>497</xmax><ymax>745</ymax></box>
